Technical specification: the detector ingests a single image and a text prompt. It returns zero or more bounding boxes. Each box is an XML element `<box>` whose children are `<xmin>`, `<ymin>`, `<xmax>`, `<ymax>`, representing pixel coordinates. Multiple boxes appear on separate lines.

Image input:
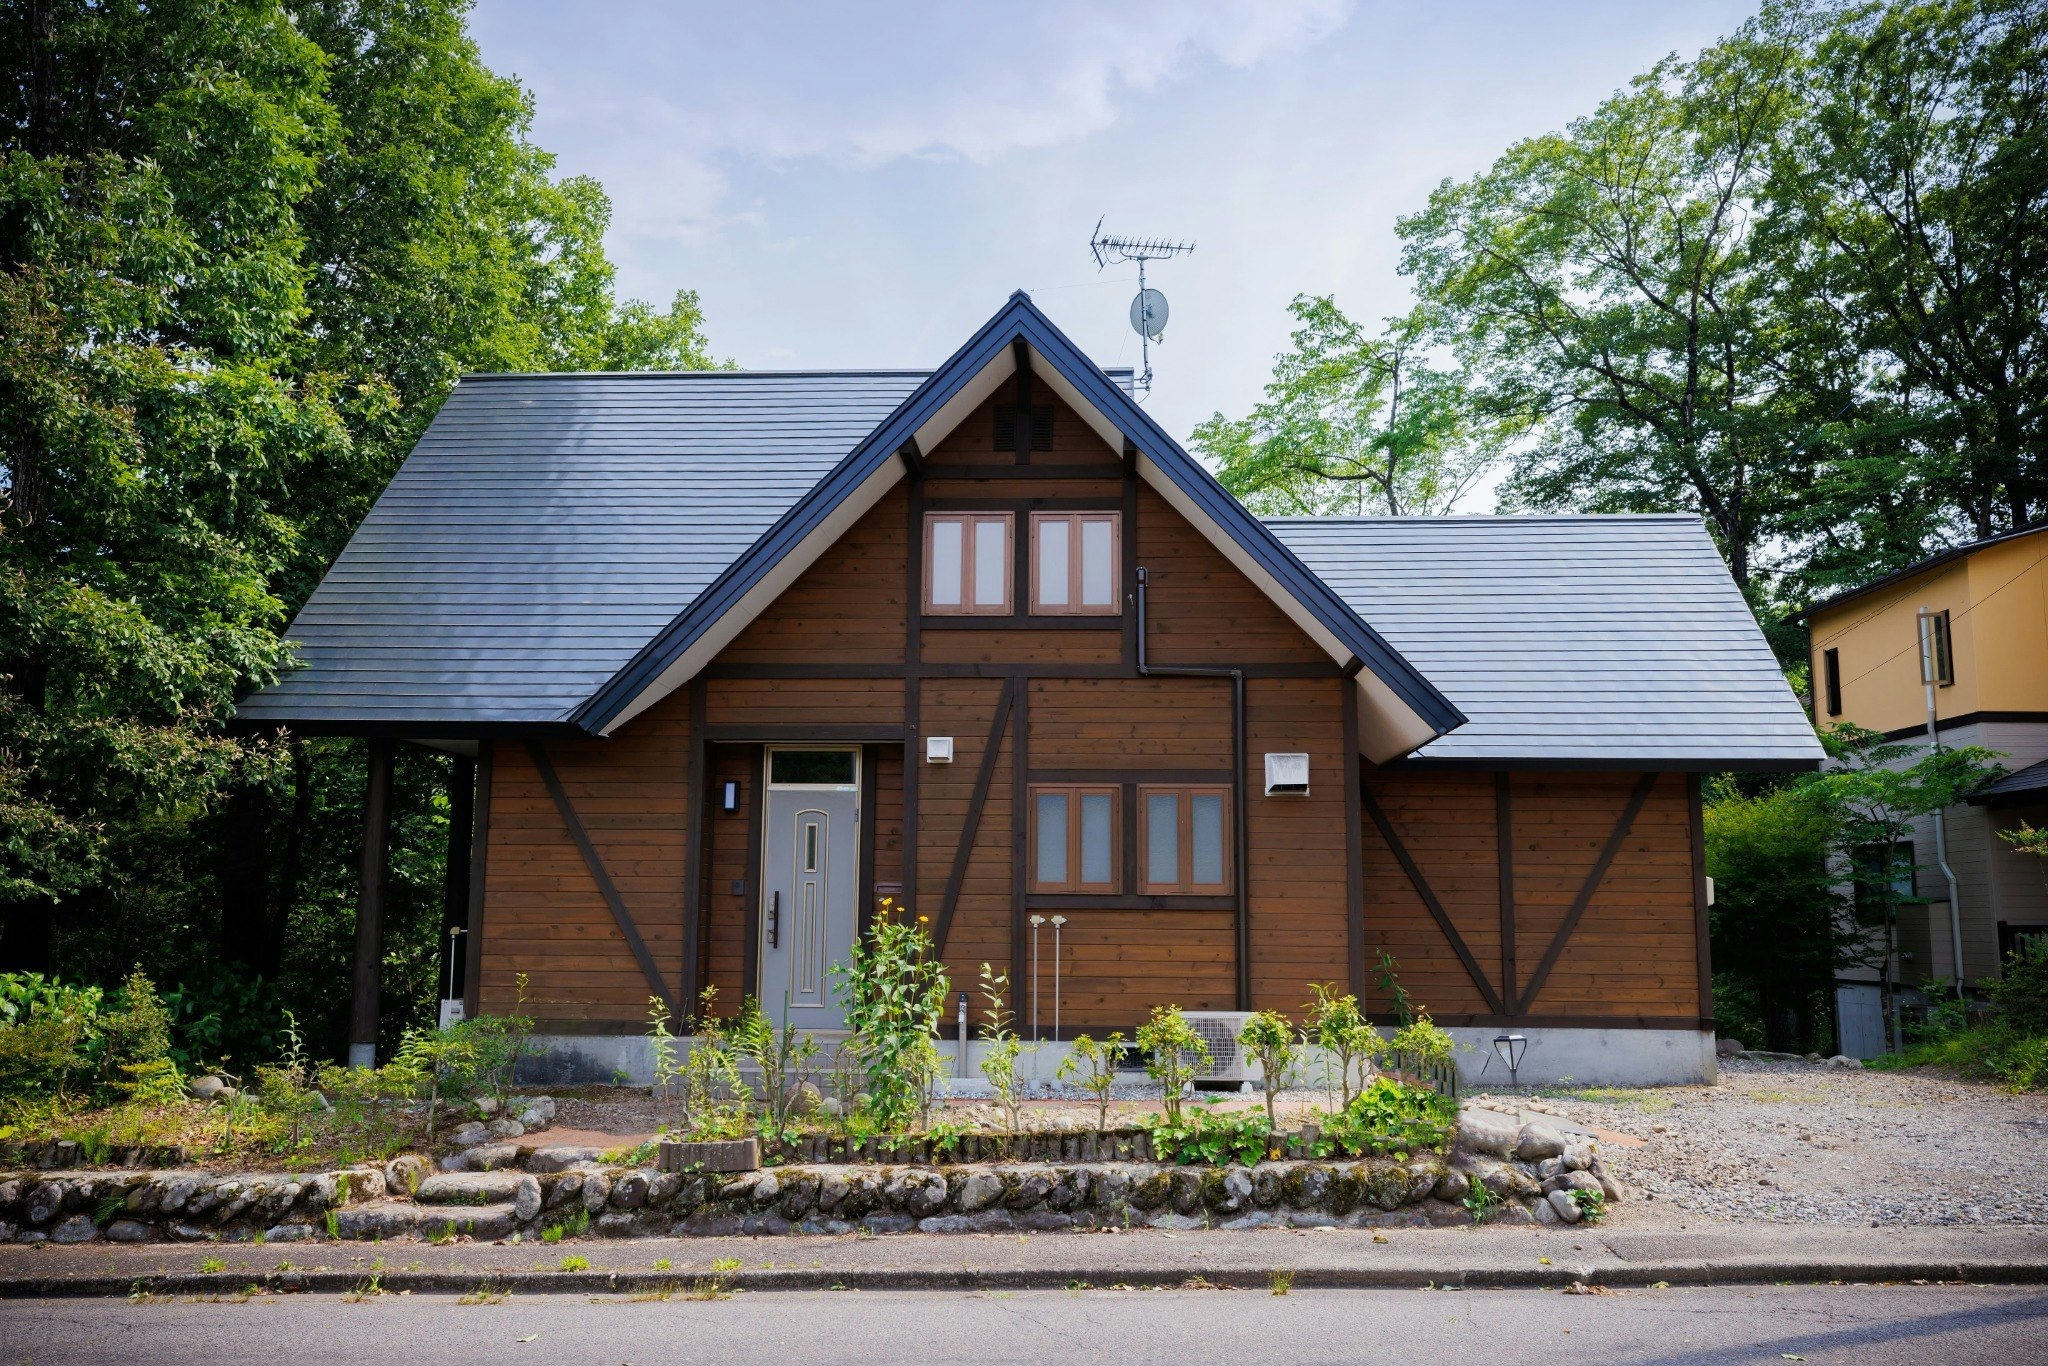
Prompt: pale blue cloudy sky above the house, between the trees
<box><xmin>471</xmin><ymin>0</ymin><xmax>1755</xmax><ymax>510</ymax></box>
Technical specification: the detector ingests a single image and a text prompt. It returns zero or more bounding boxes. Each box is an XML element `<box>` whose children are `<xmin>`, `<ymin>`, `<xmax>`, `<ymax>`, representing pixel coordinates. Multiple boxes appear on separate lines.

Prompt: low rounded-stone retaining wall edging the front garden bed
<box><xmin>0</xmin><ymin>1110</ymin><xmax>1620</xmax><ymax>1243</ymax></box>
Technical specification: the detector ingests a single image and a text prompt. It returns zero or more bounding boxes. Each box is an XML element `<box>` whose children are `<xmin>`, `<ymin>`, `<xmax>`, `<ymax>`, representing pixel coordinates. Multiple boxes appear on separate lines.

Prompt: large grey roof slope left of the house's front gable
<box><xmin>238</xmin><ymin>371</ymin><xmax>926</xmax><ymax>733</ymax></box>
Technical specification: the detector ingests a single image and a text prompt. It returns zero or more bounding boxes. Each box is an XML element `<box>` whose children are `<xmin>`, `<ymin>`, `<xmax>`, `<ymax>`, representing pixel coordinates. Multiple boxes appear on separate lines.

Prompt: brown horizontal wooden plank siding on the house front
<box><xmin>479</xmin><ymin>374</ymin><xmax>1704</xmax><ymax>1032</ymax></box>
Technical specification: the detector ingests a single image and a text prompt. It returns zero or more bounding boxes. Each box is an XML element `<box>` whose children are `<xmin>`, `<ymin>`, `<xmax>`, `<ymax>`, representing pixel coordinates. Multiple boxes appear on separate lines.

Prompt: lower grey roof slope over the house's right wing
<box><xmin>1268</xmin><ymin>516</ymin><xmax>1821</xmax><ymax>768</ymax></box>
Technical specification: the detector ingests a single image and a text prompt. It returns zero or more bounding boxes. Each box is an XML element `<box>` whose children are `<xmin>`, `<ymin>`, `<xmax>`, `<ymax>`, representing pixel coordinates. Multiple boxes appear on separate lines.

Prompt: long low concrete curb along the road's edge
<box><xmin>0</xmin><ymin>1257</ymin><xmax>2048</xmax><ymax>1298</ymax></box>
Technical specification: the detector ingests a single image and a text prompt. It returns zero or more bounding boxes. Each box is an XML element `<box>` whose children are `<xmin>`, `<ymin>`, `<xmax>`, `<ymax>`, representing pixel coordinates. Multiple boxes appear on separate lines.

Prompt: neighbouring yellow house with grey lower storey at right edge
<box><xmin>1802</xmin><ymin>524</ymin><xmax>2048</xmax><ymax>1051</ymax></box>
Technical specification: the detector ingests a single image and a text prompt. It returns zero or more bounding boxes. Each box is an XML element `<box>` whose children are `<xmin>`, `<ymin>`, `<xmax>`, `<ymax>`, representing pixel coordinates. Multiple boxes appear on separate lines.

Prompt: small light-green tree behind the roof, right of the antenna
<box><xmin>1192</xmin><ymin>295</ymin><xmax>1501</xmax><ymax>516</ymax></box>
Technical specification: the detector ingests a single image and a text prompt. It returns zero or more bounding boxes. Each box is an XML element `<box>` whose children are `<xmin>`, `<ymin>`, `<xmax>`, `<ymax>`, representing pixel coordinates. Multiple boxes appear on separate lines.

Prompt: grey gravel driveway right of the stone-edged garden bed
<box><xmin>1544</xmin><ymin>1059</ymin><xmax>2048</xmax><ymax>1227</ymax></box>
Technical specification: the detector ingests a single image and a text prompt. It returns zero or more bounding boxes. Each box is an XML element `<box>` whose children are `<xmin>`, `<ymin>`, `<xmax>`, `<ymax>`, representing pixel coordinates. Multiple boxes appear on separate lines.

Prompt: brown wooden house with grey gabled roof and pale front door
<box><xmin>240</xmin><ymin>293</ymin><xmax>1819</xmax><ymax>1081</ymax></box>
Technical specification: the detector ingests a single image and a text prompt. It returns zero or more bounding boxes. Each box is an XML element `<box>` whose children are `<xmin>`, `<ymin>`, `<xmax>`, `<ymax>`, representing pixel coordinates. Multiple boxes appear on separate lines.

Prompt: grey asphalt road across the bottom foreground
<box><xmin>0</xmin><ymin>1286</ymin><xmax>2048</xmax><ymax>1366</ymax></box>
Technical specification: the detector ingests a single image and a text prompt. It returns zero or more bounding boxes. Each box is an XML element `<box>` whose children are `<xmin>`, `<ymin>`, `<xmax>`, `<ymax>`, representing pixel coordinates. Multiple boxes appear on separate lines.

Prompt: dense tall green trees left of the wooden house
<box><xmin>0</xmin><ymin>0</ymin><xmax>709</xmax><ymax>1064</ymax></box>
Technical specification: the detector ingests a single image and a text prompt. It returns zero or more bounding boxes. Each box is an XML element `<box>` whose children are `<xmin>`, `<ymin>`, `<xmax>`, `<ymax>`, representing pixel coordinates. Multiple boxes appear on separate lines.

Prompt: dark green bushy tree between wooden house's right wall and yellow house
<box><xmin>1704</xmin><ymin>780</ymin><xmax>1862</xmax><ymax>1053</ymax></box>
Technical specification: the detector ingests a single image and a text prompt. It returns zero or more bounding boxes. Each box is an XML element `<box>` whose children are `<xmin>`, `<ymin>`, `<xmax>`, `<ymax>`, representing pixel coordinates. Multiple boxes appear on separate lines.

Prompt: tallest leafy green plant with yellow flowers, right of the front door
<box><xmin>831</xmin><ymin>897</ymin><xmax>946</xmax><ymax>1133</ymax></box>
